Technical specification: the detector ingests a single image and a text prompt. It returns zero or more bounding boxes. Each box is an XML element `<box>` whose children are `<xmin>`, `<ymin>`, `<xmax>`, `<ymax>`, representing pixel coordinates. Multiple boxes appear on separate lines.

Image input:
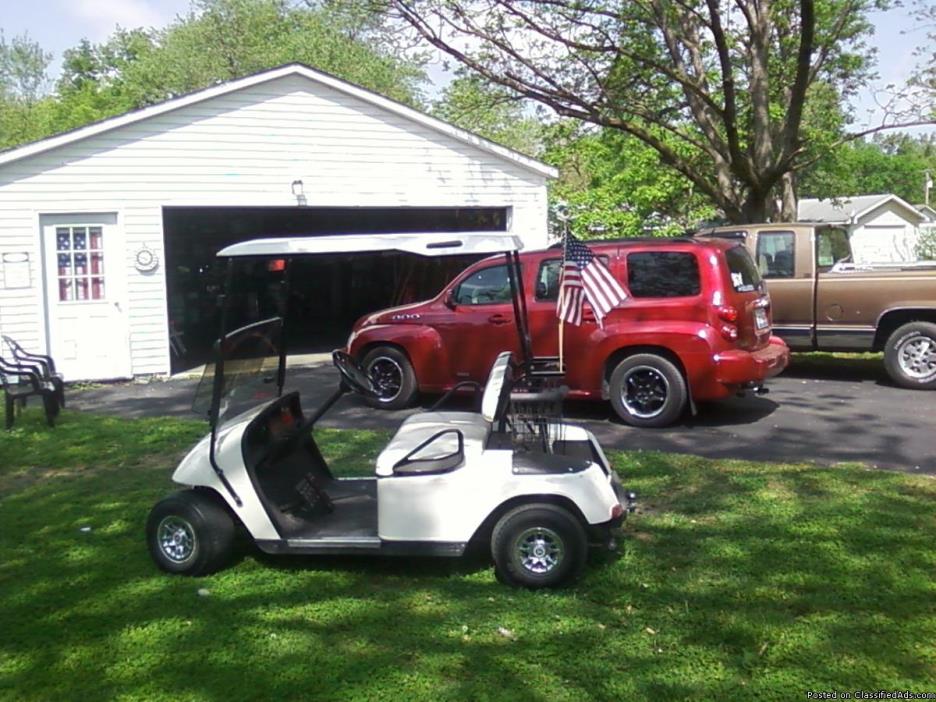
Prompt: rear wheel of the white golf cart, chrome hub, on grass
<box><xmin>491</xmin><ymin>504</ymin><xmax>588</xmax><ymax>588</ymax></box>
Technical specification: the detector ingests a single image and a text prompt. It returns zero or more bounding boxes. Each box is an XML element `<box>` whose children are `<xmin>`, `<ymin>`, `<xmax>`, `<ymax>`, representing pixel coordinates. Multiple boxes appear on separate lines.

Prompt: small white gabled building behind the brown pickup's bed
<box><xmin>798</xmin><ymin>195</ymin><xmax>925</xmax><ymax>264</ymax></box>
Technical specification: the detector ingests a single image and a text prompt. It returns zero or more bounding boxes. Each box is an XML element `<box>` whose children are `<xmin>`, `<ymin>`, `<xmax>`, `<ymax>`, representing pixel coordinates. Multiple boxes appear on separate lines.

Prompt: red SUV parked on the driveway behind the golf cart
<box><xmin>347</xmin><ymin>239</ymin><xmax>790</xmax><ymax>427</ymax></box>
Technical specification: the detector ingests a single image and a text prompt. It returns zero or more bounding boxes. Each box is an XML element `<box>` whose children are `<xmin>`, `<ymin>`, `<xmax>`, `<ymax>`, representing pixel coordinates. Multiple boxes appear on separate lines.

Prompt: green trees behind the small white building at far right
<box><xmin>799</xmin><ymin>134</ymin><xmax>936</xmax><ymax>204</ymax></box>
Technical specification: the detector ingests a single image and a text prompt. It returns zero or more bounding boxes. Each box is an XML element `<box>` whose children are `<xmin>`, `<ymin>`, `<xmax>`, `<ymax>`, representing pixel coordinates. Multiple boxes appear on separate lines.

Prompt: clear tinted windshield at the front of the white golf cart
<box><xmin>192</xmin><ymin>317</ymin><xmax>285</xmax><ymax>428</ymax></box>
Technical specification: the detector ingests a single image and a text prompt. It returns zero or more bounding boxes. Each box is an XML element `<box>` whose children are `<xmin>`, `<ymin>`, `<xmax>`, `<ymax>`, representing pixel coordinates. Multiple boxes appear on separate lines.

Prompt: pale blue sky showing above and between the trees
<box><xmin>0</xmin><ymin>0</ymin><xmax>926</xmax><ymax>131</ymax></box>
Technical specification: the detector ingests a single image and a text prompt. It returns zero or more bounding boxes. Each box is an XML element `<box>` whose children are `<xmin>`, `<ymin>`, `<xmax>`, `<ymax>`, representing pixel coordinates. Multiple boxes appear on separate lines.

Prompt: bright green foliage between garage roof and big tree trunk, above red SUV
<box><xmin>544</xmin><ymin>121</ymin><xmax>715</xmax><ymax>238</ymax></box>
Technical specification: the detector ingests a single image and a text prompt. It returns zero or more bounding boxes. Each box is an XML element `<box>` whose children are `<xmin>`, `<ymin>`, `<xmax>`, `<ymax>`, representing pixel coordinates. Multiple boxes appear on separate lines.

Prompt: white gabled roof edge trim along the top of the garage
<box><xmin>0</xmin><ymin>63</ymin><xmax>559</xmax><ymax>178</ymax></box>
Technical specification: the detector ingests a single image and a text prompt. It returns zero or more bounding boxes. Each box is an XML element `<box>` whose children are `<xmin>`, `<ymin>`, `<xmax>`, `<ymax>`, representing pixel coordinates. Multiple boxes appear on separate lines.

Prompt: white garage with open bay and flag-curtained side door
<box><xmin>0</xmin><ymin>65</ymin><xmax>556</xmax><ymax>380</ymax></box>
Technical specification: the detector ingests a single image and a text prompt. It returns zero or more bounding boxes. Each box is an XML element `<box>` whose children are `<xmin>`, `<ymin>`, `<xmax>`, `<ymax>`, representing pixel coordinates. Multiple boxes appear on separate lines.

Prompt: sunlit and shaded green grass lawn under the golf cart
<box><xmin>0</xmin><ymin>411</ymin><xmax>936</xmax><ymax>702</ymax></box>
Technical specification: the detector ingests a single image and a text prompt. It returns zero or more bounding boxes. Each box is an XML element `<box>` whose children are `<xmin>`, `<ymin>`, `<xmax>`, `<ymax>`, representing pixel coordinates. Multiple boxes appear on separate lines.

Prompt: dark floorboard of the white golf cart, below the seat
<box><xmin>279</xmin><ymin>478</ymin><xmax>377</xmax><ymax>540</ymax></box>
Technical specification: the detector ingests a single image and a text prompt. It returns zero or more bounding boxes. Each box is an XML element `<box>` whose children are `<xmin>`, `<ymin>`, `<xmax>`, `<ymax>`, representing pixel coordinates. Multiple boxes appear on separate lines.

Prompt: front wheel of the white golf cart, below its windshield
<box><xmin>146</xmin><ymin>490</ymin><xmax>234</xmax><ymax>575</ymax></box>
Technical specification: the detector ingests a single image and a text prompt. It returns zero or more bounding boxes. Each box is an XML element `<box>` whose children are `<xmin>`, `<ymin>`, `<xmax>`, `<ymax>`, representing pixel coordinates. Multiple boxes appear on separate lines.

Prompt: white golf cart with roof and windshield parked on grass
<box><xmin>146</xmin><ymin>233</ymin><xmax>634</xmax><ymax>587</ymax></box>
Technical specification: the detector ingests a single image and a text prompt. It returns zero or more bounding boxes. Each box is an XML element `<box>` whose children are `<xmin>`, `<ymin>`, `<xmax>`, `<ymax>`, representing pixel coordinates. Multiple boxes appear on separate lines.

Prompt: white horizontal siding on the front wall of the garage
<box><xmin>0</xmin><ymin>74</ymin><xmax>547</xmax><ymax>375</ymax></box>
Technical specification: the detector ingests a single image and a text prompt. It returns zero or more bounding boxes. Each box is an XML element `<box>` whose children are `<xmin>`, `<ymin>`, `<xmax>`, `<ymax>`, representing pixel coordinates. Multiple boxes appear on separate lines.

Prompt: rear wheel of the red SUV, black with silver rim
<box><xmin>609</xmin><ymin>353</ymin><xmax>688</xmax><ymax>427</ymax></box>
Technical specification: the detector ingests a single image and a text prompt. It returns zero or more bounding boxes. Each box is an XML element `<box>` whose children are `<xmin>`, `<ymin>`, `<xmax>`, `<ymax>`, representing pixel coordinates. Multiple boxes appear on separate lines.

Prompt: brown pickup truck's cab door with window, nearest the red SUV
<box><xmin>748</xmin><ymin>229</ymin><xmax>815</xmax><ymax>350</ymax></box>
